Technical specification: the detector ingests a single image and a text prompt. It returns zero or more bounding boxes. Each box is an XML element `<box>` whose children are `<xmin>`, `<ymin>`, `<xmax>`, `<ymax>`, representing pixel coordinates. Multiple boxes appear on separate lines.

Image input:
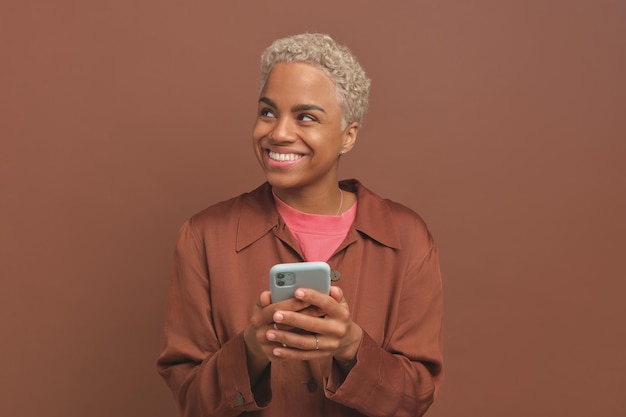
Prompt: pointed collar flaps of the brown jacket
<box><xmin>236</xmin><ymin>179</ymin><xmax>400</xmax><ymax>252</ymax></box>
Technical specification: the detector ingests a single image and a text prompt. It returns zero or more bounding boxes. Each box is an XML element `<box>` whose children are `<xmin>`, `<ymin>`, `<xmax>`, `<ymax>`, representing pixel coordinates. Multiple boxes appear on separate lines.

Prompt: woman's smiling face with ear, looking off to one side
<box><xmin>253</xmin><ymin>62</ymin><xmax>358</xmax><ymax>191</ymax></box>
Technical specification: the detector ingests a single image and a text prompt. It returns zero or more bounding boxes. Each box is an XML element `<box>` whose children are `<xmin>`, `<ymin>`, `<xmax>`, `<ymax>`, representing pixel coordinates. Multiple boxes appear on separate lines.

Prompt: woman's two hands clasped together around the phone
<box><xmin>244</xmin><ymin>287</ymin><xmax>363</xmax><ymax>385</ymax></box>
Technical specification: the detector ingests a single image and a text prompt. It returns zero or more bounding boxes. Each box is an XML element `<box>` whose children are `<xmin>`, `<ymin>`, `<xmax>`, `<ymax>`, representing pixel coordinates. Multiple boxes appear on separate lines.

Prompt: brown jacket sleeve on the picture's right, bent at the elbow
<box><xmin>325</xmin><ymin>240</ymin><xmax>443</xmax><ymax>417</ymax></box>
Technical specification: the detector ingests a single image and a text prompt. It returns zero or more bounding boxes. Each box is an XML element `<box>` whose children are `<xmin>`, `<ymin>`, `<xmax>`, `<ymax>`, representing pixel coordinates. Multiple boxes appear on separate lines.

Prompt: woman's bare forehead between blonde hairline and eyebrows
<box><xmin>261</xmin><ymin>62</ymin><xmax>339</xmax><ymax>106</ymax></box>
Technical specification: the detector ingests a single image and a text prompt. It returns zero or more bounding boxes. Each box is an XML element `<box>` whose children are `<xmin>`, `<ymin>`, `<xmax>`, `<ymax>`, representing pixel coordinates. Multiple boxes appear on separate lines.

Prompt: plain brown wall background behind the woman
<box><xmin>0</xmin><ymin>0</ymin><xmax>626</xmax><ymax>417</ymax></box>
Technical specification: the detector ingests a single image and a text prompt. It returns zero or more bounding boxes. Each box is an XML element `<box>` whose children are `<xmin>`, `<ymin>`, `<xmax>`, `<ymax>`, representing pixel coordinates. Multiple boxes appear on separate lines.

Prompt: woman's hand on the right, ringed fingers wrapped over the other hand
<box><xmin>266</xmin><ymin>286</ymin><xmax>363</xmax><ymax>368</ymax></box>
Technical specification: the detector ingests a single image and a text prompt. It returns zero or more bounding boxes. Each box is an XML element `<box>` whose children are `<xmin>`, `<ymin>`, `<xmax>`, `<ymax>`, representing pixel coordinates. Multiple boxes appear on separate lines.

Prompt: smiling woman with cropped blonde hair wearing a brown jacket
<box><xmin>158</xmin><ymin>34</ymin><xmax>443</xmax><ymax>417</ymax></box>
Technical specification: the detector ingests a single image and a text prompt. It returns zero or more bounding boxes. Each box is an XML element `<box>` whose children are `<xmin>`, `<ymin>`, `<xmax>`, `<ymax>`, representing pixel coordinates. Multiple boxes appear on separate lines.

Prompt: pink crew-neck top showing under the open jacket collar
<box><xmin>274</xmin><ymin>194</ymin><xmax>357</xmax><ymax>262</ymax></box>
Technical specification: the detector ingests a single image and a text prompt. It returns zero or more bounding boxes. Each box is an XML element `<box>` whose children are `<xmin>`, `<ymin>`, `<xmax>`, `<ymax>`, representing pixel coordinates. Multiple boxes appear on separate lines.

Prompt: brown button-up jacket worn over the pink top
<box><xmin>157</xmin><ymin>180</ymin><xmax>443</xmax><ymax>417</ymax></box>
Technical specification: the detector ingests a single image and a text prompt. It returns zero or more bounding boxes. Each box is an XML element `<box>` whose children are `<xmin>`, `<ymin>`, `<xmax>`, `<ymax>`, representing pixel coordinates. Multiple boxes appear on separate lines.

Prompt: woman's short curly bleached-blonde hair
<box><xmin>259</xmin><ymin>33</ymin><xmax>371</xmax><ymax>125</ymax></box>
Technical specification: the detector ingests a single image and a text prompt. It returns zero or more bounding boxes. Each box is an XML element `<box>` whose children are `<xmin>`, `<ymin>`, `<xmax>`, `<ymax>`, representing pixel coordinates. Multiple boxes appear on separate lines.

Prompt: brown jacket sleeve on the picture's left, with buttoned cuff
<box><xmin>157</xmin><ymin>220</ymin><xmax>269</xmax><ymax>417</ymax></box>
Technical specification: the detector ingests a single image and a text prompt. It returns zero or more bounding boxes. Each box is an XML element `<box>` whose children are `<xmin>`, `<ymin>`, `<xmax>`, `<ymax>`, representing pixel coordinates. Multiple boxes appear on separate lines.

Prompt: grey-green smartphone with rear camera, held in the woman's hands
<box><xmin>270</xmin><ymin>262</ymin><xmax>330</xmax><ymax>303</ymax></box>
